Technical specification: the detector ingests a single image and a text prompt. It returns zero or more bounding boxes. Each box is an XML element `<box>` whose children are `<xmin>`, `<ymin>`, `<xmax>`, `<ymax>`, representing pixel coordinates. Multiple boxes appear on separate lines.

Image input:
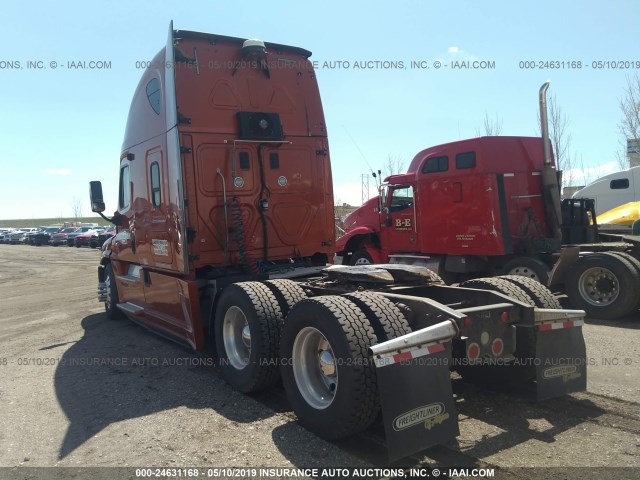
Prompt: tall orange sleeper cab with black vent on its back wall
<box><xmin>95</xmin><ymin>23</ymin><xmax>335</xmax><ymax>348</ymax></box>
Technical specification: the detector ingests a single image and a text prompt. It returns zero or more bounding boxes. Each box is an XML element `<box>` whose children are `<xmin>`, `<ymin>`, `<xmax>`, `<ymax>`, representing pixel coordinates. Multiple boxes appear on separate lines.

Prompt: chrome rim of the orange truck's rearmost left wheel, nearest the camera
<box><xmin>291</xmin><ymin>327</ymin><xmax>338</xmax><ymax>410</ymax></box>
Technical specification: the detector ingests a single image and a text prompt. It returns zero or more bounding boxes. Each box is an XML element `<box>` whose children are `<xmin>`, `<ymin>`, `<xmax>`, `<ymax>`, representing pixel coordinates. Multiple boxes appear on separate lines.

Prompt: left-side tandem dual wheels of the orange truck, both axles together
<box><xmin>214</xmin><ymin>280</ymin><xmax>410</xmax><ymax>438</ymax></box>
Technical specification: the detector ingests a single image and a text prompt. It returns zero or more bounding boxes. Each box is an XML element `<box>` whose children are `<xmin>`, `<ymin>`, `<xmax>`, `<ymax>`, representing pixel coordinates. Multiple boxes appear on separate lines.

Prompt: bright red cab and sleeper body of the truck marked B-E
<box><xmin>336</xmin><ymin>137</ymin><xmax>559</xmax><ymax>281</ymax></box>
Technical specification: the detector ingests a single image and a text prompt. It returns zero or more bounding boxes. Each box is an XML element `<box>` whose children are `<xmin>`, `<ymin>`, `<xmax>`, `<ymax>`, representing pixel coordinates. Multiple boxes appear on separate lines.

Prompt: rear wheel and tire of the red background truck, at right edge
<box><xmin>565</xmin><ymin>252</ymin><xmax>640</xmax><ymax>320</ymax></box>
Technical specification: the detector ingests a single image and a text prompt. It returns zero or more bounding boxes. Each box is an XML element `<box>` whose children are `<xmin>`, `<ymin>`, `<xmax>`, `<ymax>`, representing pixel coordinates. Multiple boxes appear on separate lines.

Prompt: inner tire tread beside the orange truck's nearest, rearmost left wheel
<box><xmin>344</xmin><ymin>292</ymin><xmax>411</xmax><ymax>343</ymax></box>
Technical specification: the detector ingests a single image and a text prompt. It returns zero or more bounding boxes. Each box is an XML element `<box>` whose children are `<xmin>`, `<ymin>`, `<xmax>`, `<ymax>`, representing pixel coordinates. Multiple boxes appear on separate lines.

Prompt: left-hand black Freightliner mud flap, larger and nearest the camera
<box><xmin>376</xmin><ymin>342</ymin><xmax>460</xmax><ymax>461</ymax></box>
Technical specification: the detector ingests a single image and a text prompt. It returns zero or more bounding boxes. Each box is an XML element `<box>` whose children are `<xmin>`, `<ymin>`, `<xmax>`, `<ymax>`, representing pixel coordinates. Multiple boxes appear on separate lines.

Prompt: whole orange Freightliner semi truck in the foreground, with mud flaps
<box><xmin>90</xmin><ymin>26</ymin><xmax>586</xmax><ymax>459</ymax></box>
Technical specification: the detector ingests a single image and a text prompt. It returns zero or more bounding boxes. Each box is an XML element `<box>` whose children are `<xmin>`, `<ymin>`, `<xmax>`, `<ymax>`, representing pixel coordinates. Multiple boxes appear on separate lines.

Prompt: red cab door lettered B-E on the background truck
<box><xmin>380</xmin><ymin>185</ymin><xmax>418</xmax><ymax>253</ymax></box>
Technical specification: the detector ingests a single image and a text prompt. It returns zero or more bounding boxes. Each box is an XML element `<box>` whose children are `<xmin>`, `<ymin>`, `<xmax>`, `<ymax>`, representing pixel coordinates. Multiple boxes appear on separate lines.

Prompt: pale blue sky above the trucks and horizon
<box><xmin>0</xmin><ymin>0</ymin><xmax>640</xmax><ymax>219</ymax></box>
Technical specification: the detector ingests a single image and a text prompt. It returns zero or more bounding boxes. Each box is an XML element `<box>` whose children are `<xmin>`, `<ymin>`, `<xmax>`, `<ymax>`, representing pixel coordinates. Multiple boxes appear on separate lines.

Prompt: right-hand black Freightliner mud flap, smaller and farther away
<box><xmin>535</xmin><ymin>323</ymin><xmax>587</xmax><ymax>400</ymax></box>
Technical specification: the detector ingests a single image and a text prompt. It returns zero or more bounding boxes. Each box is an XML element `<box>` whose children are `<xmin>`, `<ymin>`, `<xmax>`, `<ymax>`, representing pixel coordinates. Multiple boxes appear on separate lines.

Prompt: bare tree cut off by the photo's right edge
<box><xmin>617</xmin><ymin>74</ymin><xmax>640</xmax><ymax>169</ymax></box>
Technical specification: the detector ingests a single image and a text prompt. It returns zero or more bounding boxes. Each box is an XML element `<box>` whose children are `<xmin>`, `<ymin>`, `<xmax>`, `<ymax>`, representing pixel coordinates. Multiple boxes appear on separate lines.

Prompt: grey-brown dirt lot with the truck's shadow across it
<box><xmin>0</xmin><ymin>245</ymin><xmax>640</xmax><ymax>479</ymax></box>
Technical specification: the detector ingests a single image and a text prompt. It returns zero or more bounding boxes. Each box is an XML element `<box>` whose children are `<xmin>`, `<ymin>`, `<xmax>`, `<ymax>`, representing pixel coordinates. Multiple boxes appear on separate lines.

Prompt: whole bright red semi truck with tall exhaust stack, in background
<box><xmin>336</xmin><ymin>83</ymin><xmax>640</xmax><ymax>318</ymax></box>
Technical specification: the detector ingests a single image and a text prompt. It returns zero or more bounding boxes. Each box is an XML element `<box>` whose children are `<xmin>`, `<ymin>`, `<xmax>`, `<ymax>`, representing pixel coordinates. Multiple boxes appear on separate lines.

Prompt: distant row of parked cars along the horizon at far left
<box><xmin>0</xmin><ymin>225</ymin><xmax>116</xmax><ymax>248</ymax></box>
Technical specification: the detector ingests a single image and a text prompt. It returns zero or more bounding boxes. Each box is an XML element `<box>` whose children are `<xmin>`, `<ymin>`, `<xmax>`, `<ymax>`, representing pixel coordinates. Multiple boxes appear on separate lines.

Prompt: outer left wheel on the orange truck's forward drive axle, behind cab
<box><xmin>214</xmin><ymin>282</ymin><xmax>283</xmax><ymax>393</ymax></box>
